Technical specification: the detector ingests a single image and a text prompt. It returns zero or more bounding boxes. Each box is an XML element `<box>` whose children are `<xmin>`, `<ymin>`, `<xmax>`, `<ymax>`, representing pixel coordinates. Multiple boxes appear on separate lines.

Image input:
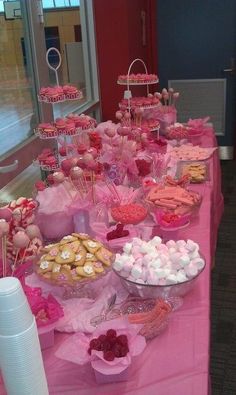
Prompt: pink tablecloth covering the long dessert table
<box><xmin>0</xmin><ymin>128</ymin><xmax>223</xmax><ymax>395</ymax></box>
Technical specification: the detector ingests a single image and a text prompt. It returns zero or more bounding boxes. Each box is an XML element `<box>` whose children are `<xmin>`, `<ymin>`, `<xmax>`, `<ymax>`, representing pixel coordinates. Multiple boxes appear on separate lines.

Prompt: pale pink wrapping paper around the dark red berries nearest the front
<box><xmin>55</xmin><ymin>317</ymin><xmax>146</xmax><ymax>375</ymax></box>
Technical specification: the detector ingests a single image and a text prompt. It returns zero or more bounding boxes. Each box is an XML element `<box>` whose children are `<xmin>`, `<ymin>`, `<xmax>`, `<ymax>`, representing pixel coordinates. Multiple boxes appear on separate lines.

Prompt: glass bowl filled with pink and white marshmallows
<box><xmin>113</xmin><ymin>236</ymin><xmax>205</xmax><ymax>299</ymax></box>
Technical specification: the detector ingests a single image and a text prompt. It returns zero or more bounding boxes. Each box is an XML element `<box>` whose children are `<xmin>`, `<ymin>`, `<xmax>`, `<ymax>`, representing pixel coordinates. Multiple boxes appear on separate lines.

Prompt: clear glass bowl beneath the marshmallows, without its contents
<box><xmin>113</xmin><ymin>259</ymin><xmax>206</xmax><ymax>300</ymax></box>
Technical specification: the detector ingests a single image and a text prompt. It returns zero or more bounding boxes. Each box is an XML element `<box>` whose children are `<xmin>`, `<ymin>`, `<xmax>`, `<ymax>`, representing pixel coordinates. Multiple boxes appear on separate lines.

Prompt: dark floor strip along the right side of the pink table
<box><xmin>210</xmin><ymin>161</ymin><xmax>236</xmax><ymax>395</ymax></box>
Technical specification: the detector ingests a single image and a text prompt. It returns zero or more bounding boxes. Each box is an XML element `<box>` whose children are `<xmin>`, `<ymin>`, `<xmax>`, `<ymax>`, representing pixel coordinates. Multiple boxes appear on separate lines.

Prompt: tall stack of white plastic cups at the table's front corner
<box><xmin>0</xmin><ymin>277</ymin><xmax>48</xmax><ymax>395</ymax></box>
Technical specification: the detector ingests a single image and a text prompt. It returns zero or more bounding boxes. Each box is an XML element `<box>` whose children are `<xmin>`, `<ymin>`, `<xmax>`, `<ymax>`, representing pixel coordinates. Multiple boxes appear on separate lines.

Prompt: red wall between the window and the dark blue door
<box><xmin>93</xmin><ymin>0</ymin><xmax>157</xmax><ymax>120</ymax></box>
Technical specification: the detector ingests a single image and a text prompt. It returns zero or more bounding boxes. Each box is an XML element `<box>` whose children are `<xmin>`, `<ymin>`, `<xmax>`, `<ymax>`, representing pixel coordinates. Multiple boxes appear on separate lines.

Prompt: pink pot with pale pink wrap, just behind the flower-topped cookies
<box><xmin>36</xmin><ymin>183</ymin><xmax>77</xmax><ymax>240</ymax></box>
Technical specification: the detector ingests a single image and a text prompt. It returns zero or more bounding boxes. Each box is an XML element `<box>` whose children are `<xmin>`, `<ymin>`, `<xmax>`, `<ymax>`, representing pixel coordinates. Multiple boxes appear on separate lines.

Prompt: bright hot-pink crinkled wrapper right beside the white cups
<box><xmin>23</xmin><ymin>285</ymin><xmax>64</xmax><ymax>328</ymax></box>
